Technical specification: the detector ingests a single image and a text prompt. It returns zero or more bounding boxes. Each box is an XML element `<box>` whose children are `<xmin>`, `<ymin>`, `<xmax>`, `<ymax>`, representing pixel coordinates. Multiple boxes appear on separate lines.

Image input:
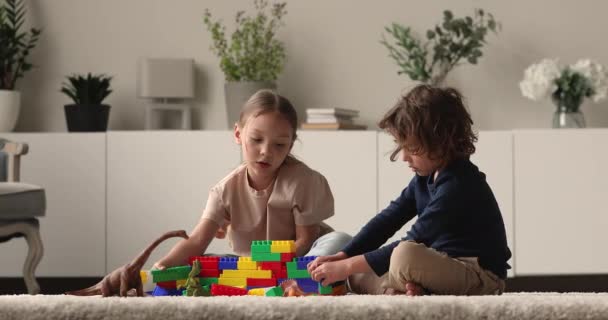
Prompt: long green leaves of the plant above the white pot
<box><xmin>0</xmin><ymin>0</ymin><xmax>42</xmax><ymax>90</ymax></box>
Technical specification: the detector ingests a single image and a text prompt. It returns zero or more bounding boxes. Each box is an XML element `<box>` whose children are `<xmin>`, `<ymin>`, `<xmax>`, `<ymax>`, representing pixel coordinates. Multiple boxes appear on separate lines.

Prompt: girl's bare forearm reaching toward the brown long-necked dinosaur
<box><xmin>154</xmin><ymin>218</ymin><xmax>220</xmax><ymax>269</ymax></box>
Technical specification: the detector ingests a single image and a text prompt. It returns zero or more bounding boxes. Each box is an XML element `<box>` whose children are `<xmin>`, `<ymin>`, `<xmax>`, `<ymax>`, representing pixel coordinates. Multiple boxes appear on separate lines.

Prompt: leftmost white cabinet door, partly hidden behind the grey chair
<box><xmin>0</xmin><ymin>133</ymin><xmax>106</xmax><ymax>277</ymax></box>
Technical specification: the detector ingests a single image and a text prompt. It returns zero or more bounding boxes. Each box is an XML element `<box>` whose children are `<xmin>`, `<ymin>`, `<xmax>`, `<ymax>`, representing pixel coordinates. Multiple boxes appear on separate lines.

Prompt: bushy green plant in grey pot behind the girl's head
<box><xmin>203</xmin><ymin>0</ymin><xmax>287</xmax><ymax>128</ymax></box>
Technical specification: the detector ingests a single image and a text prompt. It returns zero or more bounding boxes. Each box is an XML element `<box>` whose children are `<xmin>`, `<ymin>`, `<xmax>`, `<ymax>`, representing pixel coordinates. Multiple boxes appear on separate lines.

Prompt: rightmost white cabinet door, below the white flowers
<box><xmin>514</xmin><ymin>129</ymin><xmax>608</xmax><ymax>275</ymax></box>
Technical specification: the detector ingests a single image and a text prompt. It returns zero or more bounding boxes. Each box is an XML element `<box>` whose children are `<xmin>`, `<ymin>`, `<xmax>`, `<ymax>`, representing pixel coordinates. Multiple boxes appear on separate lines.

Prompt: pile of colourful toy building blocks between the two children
<box><xmin>151</xmin><ymin>240</ymin><xmax>345</xmax><ymax>297</ymax></box>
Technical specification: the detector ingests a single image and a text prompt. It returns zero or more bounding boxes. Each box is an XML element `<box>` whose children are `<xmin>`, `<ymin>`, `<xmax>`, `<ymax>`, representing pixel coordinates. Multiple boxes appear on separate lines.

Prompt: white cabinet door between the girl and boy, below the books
<box><xmin>293</xmin><ymin>131</ymin><xmax>376</xmax><ymax>235</ymax></box>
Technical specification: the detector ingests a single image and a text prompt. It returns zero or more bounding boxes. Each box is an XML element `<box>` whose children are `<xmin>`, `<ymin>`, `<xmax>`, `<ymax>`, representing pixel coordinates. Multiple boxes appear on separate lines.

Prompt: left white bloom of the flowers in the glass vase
<box><xmin>519</xmin><ymin>59</ymin><xmax>561</xmax><ymax>101</ymax></box>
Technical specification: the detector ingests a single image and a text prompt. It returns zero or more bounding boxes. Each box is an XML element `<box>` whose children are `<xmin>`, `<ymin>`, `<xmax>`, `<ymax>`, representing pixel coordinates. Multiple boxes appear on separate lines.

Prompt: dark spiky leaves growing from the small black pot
<box><xmin>61</xmin><ymin>72</ymin><xmax>112</xmax><ymax>105</ymax></box>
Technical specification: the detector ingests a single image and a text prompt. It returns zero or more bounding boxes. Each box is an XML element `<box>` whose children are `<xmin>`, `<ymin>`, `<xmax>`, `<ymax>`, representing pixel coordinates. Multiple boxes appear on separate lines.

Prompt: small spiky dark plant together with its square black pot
<box><xmin>61</xmin><ymin>73</ymin><xmax>112</xmax><ymax>132</ymax></box>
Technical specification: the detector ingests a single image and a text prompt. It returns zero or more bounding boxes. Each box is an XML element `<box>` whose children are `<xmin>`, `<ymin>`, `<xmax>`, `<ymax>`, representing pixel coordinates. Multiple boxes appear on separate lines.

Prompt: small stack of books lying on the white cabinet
<box><xmin>302</xmin><ymin>108</ymin><xmax>367</xmax><ymax>130</ymax></box>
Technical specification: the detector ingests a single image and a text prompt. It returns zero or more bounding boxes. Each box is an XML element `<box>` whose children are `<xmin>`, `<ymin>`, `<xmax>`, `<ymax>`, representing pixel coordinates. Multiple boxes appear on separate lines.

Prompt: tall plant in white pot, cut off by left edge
<box><xmin>0</xmin><ymin>0</ymin><xmax>42</xmax><ymax>131</ymax></box>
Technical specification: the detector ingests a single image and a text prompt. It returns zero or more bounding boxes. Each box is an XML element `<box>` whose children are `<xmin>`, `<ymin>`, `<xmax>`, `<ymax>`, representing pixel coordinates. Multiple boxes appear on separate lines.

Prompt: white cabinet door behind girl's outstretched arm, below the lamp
<box><xmin>107</xmin><ymin>131</ymin><xmax>240</xmax><ymax>271</ymax></box>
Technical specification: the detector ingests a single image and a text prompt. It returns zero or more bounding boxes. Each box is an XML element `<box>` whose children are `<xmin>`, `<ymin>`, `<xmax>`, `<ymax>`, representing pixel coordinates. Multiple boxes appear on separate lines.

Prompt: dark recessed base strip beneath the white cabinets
<box><xmin>0</xmin><ymin>274</ymin><xmax>608</xmax><ymax>295</ymax></box>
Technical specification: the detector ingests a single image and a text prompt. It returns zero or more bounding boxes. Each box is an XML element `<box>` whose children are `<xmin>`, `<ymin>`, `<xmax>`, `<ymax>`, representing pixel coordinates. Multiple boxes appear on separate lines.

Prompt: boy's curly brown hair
<box><xmin>378</xmin><ymin>84</ymin><xmax>477</xmax><ymax>164</ymax></box>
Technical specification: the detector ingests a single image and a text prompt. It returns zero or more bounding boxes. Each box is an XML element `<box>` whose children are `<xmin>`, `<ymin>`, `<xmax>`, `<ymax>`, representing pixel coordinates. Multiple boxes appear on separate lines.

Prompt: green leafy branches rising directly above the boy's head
<box><xmin>380</xmin><ymin>9</ymin><xmax>500</xmax><ymax>85</ymax></box>
